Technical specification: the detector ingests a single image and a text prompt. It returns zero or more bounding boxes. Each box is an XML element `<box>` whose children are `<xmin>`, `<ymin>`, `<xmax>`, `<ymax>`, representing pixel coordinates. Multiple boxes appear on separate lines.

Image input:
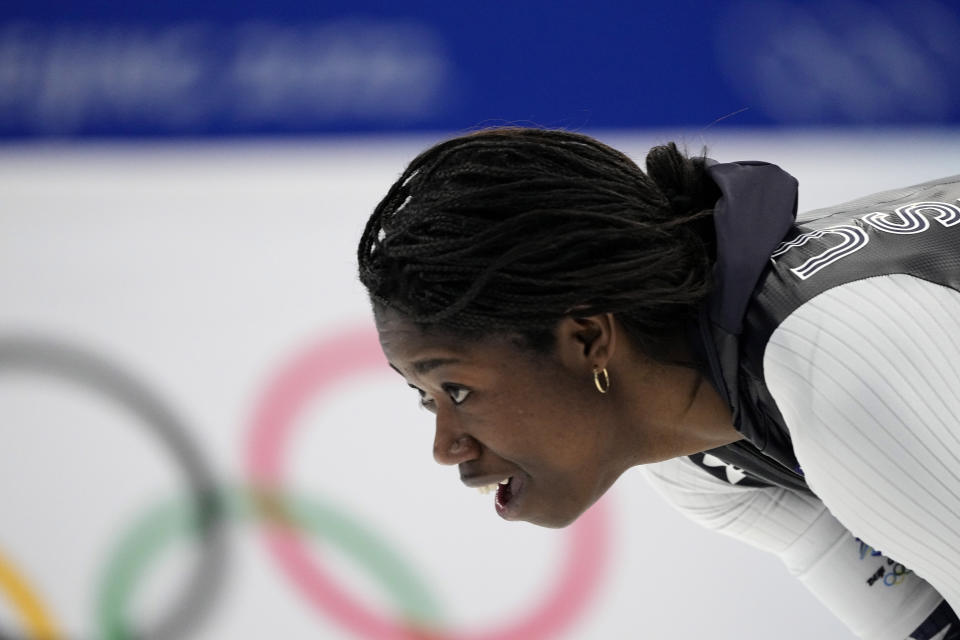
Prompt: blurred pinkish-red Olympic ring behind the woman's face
<box><xmin>247</xmin><ymin>329</ymin><xmax>609</xmax><ymax>640</ymax></box>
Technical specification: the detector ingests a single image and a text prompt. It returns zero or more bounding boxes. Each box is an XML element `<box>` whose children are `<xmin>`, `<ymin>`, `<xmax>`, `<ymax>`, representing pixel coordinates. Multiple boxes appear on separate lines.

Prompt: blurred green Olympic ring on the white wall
<box><xmin>98</xmin><ymin>489</ymin><xmax>440</xmax><ymax>640</ymax></box>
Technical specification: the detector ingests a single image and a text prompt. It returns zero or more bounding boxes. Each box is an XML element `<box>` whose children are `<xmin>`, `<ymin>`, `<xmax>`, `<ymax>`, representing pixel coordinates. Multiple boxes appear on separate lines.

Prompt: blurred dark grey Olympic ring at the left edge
<box><xmin>0</xmin><ymin>337</ymin><xmax>226</xmax><ymax>638</ymax></box>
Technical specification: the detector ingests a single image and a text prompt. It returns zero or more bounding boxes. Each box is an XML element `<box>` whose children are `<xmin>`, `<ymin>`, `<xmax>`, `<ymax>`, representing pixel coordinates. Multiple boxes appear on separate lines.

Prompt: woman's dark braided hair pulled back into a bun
<box><xmin>358</xmin><ymin>128</ymin><xmax>720</xmax><ymax>355</ymax></box>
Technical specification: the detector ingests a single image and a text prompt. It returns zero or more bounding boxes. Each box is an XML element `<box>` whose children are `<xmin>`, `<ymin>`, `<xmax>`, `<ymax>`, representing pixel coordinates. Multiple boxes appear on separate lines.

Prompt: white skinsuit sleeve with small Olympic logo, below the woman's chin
<box><xmin>644</xmin><ymin>458</ymin><xmax>953</xmax><ymax>640</ymax></box>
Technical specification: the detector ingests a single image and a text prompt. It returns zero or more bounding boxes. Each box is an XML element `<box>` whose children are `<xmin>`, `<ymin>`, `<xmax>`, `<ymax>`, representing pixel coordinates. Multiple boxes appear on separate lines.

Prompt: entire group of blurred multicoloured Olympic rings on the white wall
<box><xmin>0</xmin><ymin>331</ymin><xmax>609</xmax><ymax>640</ymax></box>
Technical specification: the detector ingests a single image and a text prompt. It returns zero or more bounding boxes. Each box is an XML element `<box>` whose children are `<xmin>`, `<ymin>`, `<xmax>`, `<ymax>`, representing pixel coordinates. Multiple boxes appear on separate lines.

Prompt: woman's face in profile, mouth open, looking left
<box><xmin>375</xmin><ymin>309</ymin><xmax>629</xmax><ymax>527</ymax></box>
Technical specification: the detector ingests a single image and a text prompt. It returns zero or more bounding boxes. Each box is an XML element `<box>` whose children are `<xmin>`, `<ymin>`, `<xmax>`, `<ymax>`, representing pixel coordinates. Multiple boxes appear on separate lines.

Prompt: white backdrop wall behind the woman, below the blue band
<box><xmin>0</xmin><ymin>130</ymin><xmax>960</xmax><ymax>640</ymax></box>
